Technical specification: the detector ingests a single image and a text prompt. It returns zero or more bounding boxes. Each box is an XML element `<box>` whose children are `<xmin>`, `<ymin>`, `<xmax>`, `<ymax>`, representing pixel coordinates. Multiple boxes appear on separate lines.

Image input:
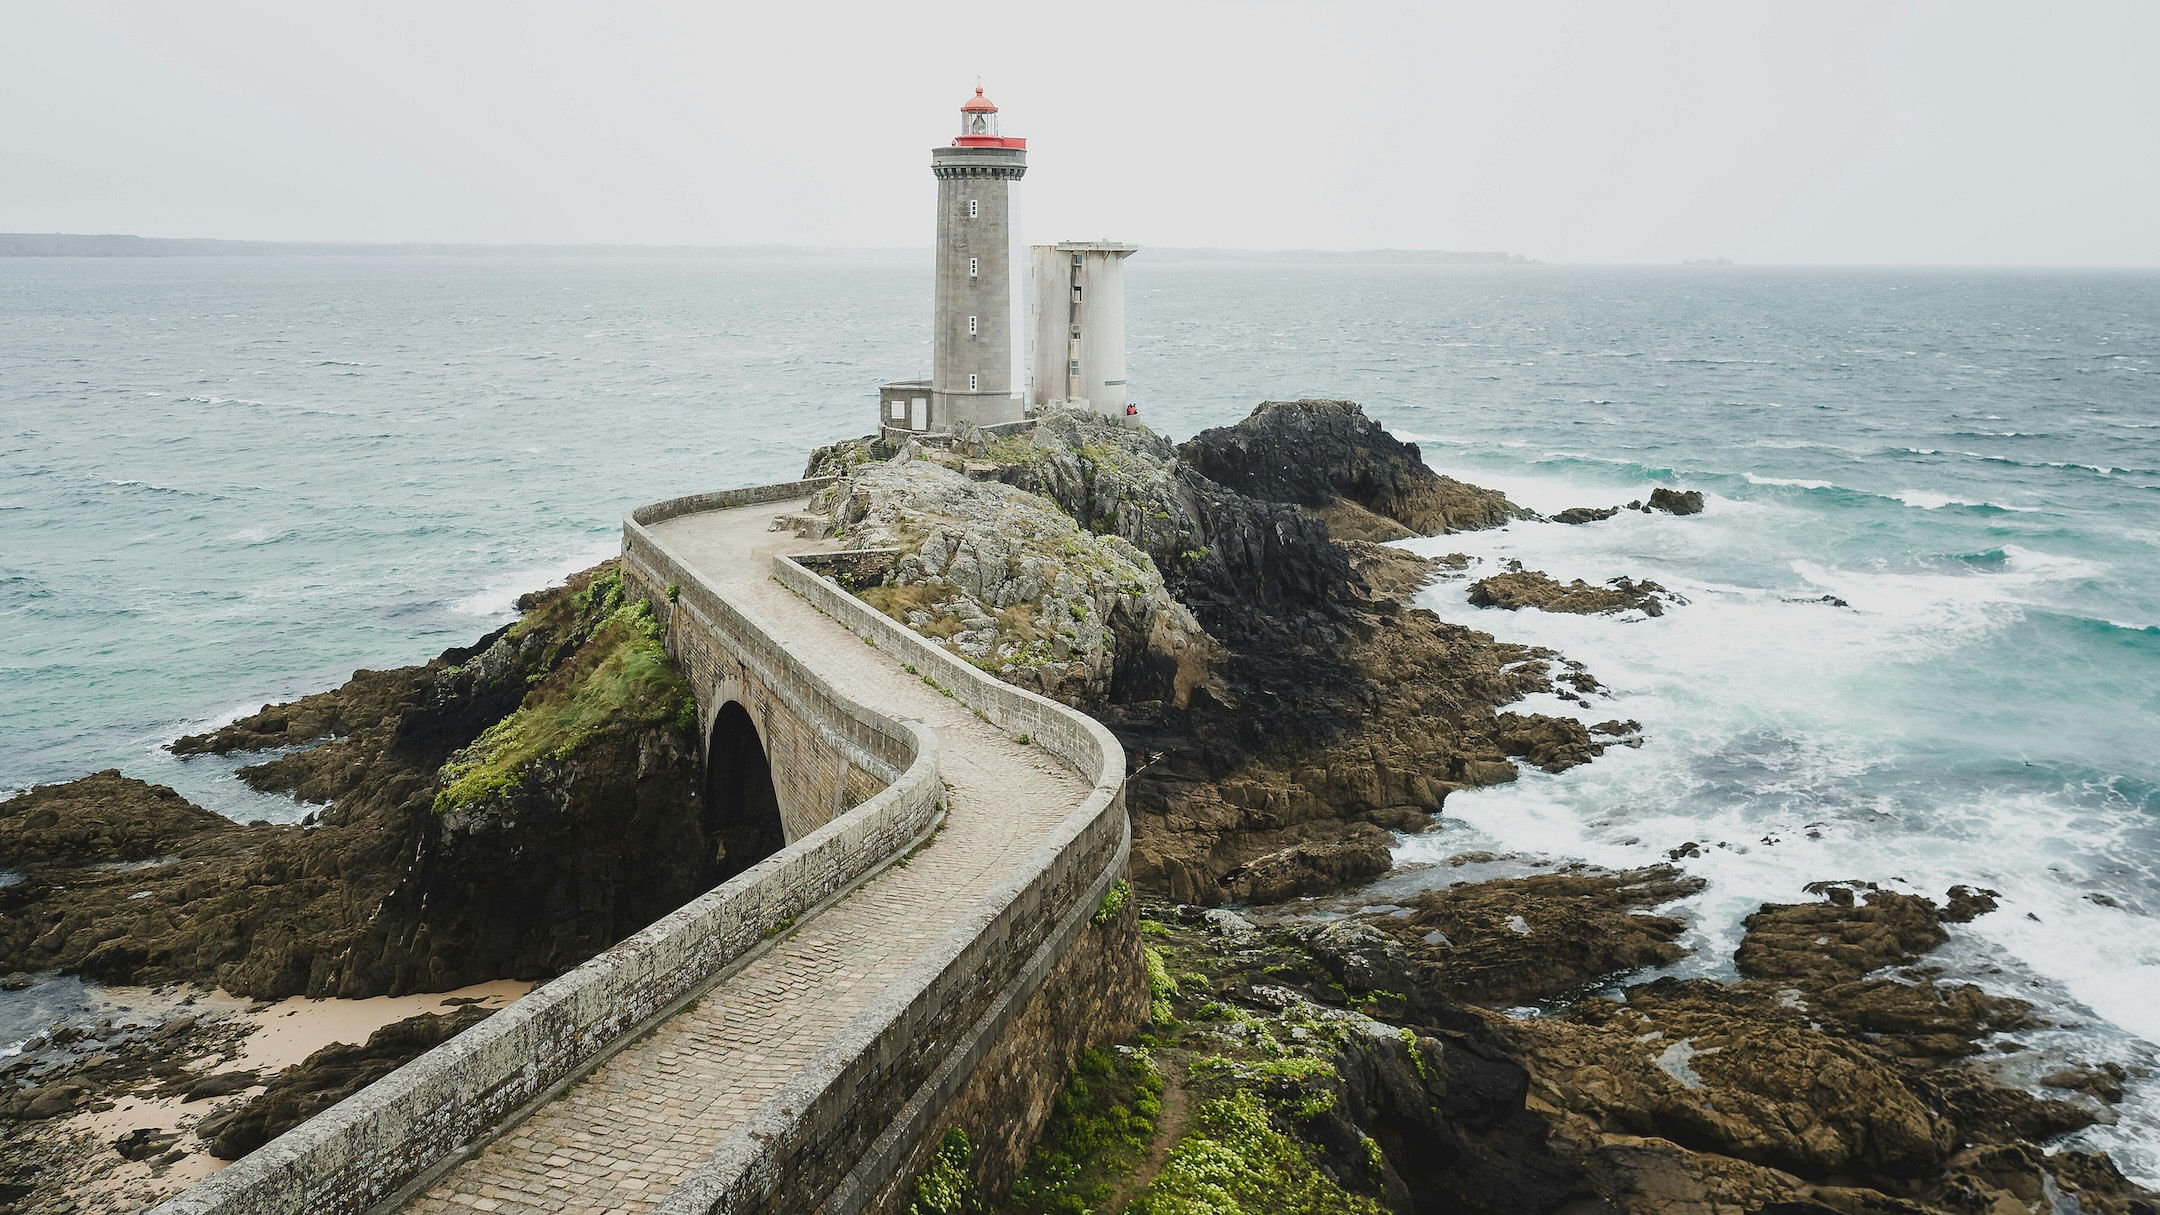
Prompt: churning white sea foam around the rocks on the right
<box><xmin>1398</xmin><ymin>476</ymin><xmax>2160</xmax><ymax>1176</ymax></box>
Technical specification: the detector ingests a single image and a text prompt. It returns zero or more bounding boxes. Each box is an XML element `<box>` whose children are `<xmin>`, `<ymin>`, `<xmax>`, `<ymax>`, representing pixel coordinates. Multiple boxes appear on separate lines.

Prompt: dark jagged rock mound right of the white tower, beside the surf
<box><xmin>1179</xmin><ymin>400</ymin><xmax>1525</xmax><ymax>529</ymax></box>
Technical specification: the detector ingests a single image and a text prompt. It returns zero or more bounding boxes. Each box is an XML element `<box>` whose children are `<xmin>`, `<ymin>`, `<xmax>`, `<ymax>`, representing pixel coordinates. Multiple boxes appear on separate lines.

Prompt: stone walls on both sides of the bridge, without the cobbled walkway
<box><xmin>158</xmin><ymin>478</ymin><xmax>1145</xmax><ymax>1215</ymax></box>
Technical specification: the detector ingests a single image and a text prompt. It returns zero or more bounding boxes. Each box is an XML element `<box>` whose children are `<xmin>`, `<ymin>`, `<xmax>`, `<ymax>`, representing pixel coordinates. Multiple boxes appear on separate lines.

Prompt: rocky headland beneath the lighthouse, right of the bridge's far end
<box><xmin>810</xmin><ymin>402</ymin><xmax>1620</xmax><ymax>902</ymax></box>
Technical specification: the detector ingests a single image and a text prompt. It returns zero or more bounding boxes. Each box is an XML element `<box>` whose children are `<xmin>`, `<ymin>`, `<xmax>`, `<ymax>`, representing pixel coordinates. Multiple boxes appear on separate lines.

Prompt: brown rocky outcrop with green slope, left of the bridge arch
<box><xmin>0</xmin><ymin>564</ymin><xmax>713</xmax><ymax>999</ymax></box>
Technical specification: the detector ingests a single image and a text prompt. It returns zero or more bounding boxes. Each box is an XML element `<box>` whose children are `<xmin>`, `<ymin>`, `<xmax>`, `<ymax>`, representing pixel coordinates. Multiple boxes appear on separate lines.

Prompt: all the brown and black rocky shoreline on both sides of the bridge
<box><xmin>0</xmin><ymin>400</ymin><xmax>2156</xmax><ymax>1215</ymax></box>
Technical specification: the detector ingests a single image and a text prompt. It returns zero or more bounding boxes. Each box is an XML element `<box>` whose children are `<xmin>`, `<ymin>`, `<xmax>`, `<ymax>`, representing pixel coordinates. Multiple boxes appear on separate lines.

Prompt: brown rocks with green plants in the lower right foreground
<box><xmin>996</xmin><ymin>867</ymin><xmax>2160</xmax><ymax>1215</ymax></box>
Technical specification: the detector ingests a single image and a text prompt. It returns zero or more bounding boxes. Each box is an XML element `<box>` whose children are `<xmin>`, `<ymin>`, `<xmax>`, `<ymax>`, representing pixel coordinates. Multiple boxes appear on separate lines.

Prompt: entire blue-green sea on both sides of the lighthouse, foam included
<box><xmin>0</xmin><ymin>253</ymin><xmax>2160</xmax><ymax>1183</ymax></box>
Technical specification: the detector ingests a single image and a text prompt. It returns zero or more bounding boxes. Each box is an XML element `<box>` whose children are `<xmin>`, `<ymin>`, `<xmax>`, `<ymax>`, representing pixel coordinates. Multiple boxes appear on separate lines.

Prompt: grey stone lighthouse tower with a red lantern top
<box><xmin>929</xmin><ymin>89</ymin><xmax>1028</xmax><ymax>430</ymax></box>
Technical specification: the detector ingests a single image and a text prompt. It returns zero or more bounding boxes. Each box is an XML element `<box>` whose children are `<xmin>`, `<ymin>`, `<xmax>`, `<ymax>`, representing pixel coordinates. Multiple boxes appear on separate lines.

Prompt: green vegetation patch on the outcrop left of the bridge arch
<box><xmin>434</xmin><ymin>569</ymin><xmax>698</xmax><ymax>813</ymax></box>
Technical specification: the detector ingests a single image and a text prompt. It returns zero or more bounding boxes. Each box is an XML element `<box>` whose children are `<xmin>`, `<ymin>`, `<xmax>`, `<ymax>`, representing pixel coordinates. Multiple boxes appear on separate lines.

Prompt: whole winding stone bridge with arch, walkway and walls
<box><xmin>160</xmin><ymin>480</ymin><xmax>1147</xmax><ymax>1215</ymax></box>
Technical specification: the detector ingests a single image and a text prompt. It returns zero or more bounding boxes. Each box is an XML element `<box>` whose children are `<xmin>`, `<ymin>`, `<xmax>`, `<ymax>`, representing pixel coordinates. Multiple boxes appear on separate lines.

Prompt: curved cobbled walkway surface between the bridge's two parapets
<box><xmin>404</xmin><ymin>502</ymin><xmax>1091</xmax><ymax>1213</ymax></box>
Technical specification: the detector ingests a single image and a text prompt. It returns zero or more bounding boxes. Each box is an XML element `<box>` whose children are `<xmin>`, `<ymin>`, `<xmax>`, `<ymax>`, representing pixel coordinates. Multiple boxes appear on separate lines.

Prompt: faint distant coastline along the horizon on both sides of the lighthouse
<box><xmin>0</xmin><ymin>231</ymin><xmax>1536</xmax><ymax>266</ymax></box>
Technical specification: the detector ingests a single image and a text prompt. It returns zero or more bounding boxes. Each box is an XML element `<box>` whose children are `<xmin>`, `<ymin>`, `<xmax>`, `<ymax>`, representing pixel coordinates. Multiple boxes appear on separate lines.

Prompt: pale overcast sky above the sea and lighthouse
<box><xmin>0</xmin><ymin>0</ymin><xmax>2160</xmax><ymax>266</ymax></box>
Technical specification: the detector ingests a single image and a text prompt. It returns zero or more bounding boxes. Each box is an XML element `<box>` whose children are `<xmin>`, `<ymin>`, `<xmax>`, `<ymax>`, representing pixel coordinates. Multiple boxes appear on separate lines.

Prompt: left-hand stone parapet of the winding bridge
<box><xmin>158</xmin><ymin>482</ymin><xmax>944</xmax><ymax>1215</ymax></box>
